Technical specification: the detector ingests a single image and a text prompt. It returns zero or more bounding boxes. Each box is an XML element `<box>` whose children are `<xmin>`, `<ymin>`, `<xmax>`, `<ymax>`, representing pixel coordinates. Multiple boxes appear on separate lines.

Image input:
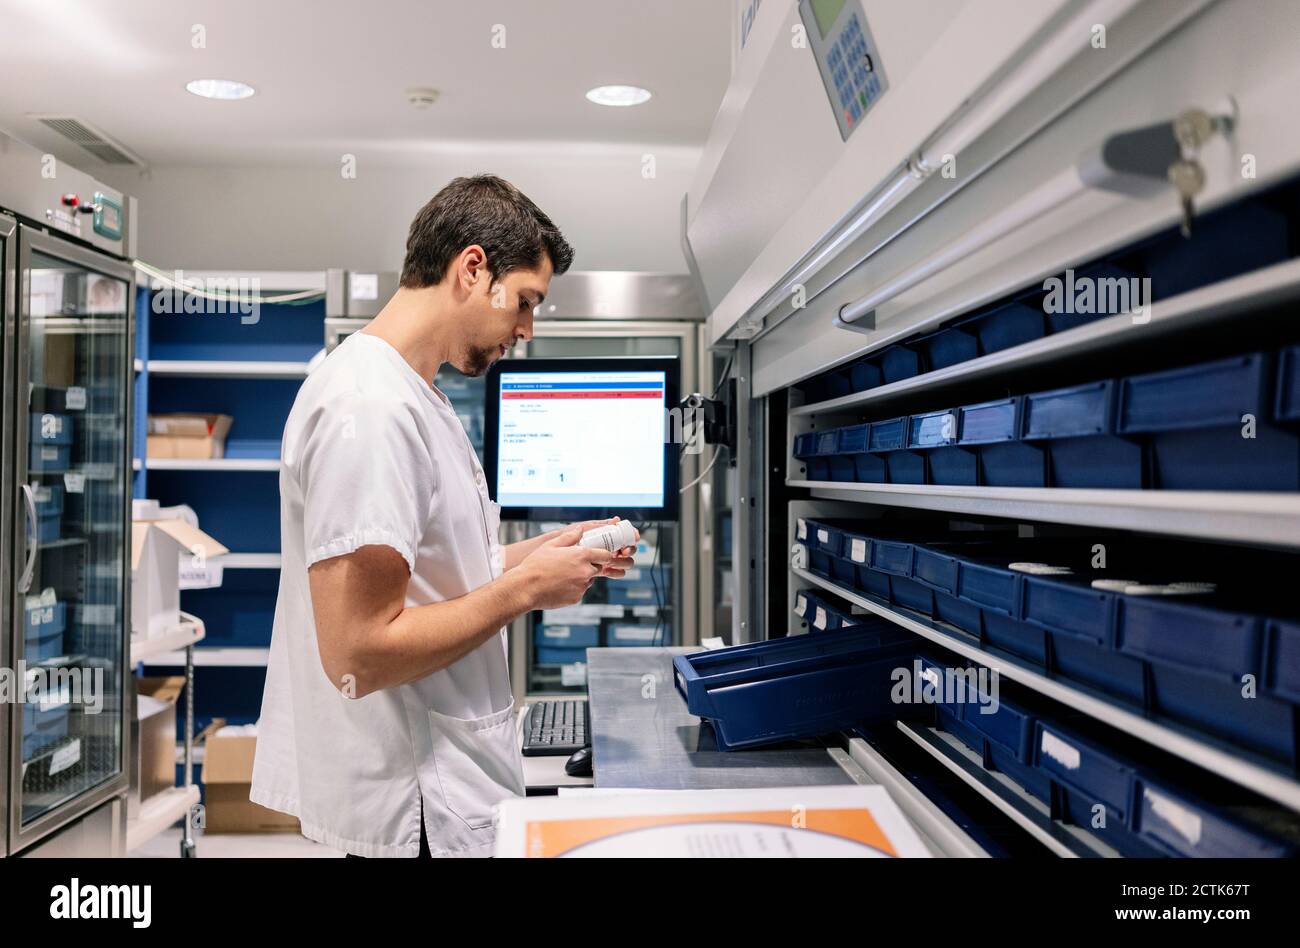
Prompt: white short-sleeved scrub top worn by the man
<box><xmin>248</xmin><ymin>332</ymin><xmax>524</xmax><ymax>857</ymax></box>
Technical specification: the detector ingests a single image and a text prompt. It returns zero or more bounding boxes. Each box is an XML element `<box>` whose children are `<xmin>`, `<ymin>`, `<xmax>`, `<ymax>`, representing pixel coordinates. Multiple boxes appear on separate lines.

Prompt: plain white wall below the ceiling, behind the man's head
<box><xmin>104</xmin><ymin>143</ymin><xmax>699</xmax><ymax>273</ymax></box>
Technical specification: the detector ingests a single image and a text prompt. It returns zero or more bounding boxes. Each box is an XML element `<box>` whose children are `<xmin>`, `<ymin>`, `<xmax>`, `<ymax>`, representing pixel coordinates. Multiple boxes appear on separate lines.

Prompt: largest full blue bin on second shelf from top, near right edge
<box><xmin>1117</xmin><ymin>352</ymin><xmax>1300</xmax><ymax>490</ymax></box>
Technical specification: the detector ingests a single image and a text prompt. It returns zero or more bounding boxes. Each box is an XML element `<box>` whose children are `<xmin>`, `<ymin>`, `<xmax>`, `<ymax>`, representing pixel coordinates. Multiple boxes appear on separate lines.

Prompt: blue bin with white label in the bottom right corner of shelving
<box><xmin>1134</xmin><ymin>774</ymin><xmax>1297</xmax><ymax>858</ymax></box>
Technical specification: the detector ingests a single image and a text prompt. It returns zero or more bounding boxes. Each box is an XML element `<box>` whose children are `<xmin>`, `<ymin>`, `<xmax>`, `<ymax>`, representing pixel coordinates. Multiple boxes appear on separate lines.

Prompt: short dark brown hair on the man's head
<box><xmin>402</xmin><ymin>174</ymin><xmax>573</xmax><ymax>289</ymax></box>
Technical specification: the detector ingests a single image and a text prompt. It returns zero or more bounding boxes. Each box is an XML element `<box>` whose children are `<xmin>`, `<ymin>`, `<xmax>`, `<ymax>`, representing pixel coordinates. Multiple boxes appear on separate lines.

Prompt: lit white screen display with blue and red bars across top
<box><xmin>497</xmin><ymin>372</ymin><xmax>667</xmax><ymax>507</ymax></box>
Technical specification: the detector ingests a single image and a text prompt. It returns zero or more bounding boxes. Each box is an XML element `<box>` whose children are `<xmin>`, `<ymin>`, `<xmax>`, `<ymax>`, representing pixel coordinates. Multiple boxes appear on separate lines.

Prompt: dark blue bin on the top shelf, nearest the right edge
<box><xmin>1143</xmin><ymin>202</ymin><xmax>1287</xmax><ymax>299</ymax></box>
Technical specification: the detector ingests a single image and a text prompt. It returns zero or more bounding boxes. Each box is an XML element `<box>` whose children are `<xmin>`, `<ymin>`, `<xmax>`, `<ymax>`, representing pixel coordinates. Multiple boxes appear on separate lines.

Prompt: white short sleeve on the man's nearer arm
<box><xmin>299</xmin><ymin>393</ymin><xmax>437</xmax><ymax>572</ymax></box>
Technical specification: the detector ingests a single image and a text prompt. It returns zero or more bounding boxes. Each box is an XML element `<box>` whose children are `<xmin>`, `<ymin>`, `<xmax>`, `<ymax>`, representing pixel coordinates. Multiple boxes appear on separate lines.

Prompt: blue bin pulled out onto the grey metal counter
<box><xmin>673</xmin><ymin>620</ymin><xmax>915</xmax><ymax>750</ymax></box>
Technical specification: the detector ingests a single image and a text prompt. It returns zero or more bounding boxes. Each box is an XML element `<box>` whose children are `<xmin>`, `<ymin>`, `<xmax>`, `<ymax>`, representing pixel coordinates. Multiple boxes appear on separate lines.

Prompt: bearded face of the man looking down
<box><xmin>451</xmin><ymin>254</ymin><xmax>551</xmax><ymax>376</ymax></box>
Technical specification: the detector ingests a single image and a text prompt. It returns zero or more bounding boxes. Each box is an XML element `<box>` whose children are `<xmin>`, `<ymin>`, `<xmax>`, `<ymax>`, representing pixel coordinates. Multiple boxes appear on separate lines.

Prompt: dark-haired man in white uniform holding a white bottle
<box><xmin>250</xmin><ymin>176</ymin><xmax>632</xmax><ymax>857</ymax></box>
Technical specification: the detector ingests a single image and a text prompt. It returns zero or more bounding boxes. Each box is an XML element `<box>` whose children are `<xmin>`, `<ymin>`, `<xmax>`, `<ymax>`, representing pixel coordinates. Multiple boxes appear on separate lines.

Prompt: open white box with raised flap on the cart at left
<box><xmin>131</xmin><ymin>520</ymin><xmax>229</xmax><ymax>639</ymax></box>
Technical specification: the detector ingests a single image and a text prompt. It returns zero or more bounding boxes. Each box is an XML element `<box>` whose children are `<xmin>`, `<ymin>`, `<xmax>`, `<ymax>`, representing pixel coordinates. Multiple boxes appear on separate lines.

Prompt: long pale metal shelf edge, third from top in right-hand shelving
<box><xmin>790</xmin><ymin>567</ymin><xmax>1300</xmax><ymax>813</ymax></box>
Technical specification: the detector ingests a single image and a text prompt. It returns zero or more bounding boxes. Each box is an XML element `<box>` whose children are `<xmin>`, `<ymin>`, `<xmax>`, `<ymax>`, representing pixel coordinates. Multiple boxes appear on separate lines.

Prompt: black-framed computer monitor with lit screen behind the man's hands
<box><xmin>484</xmin><ymin>356</ymin><xmax>679</xmax><ymax>521</ymax></box>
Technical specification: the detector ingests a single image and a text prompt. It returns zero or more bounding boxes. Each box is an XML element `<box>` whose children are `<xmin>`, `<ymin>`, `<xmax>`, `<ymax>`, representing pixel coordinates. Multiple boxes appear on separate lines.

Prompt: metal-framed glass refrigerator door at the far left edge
<box><xmin>0</xmin><ymin>223</ymin><xmax>134</xmax><ymax>854</ymax></box>
